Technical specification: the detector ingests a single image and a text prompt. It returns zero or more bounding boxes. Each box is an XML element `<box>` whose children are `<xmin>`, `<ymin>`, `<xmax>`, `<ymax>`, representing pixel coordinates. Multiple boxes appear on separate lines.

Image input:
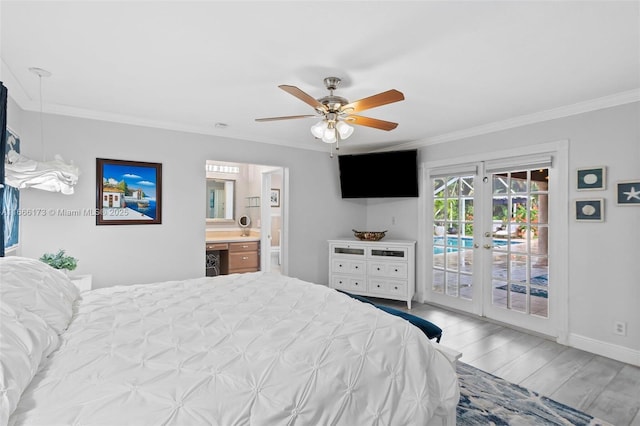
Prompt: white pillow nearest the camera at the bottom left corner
<box><xmin>0</xmin><ymin>301</ymin><xmax>59</xmax><ymax>426</ymax></box>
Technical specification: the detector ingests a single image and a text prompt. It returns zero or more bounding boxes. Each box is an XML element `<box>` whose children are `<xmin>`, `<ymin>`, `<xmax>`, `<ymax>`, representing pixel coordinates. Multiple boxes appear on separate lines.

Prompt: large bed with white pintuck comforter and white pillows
<box><xmin>0</xmin><ymin>257</ymin><xmax>459</xmax><ymax>426</ymax></box>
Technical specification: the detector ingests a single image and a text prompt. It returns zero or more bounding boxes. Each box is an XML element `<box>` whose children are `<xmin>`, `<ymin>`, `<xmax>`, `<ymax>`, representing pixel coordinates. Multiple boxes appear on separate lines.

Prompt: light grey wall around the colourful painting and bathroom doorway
<box><xmin>7</xmin><ymin>100</ymin><xmax>364</xmax><ymax>287</ymax></box>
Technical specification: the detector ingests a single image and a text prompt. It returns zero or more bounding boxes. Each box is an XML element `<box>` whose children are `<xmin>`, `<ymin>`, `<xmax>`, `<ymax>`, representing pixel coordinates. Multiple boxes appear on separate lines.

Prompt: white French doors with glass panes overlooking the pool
<box><xmin>425</xmin><ymin>155</ymin><xmax>557</xmax><ymax>335</ymax></box>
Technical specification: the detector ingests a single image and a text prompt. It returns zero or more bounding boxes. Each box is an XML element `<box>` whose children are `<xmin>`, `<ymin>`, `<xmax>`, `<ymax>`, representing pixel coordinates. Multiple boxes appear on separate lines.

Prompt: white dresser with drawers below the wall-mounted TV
<box><xmin>329</xmin><ymin>238</ymin><xmax>416</xmax><ymax>309</ymax></box>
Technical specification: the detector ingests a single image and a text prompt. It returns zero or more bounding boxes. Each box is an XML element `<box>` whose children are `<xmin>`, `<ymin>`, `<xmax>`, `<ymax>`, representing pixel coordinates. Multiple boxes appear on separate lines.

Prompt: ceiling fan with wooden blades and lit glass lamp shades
<box><xmin>256</xmin><ymin>77</ymin><xmax>404</xmax><ymax>149</ymax></box>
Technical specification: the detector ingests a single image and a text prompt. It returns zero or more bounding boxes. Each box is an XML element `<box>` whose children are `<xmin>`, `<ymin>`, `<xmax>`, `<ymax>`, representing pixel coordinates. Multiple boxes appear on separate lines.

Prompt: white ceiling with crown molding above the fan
<box><xmin>0</xmin><ymin>0</ymin><xmax>640</xmax><ymax>152</ymax></box>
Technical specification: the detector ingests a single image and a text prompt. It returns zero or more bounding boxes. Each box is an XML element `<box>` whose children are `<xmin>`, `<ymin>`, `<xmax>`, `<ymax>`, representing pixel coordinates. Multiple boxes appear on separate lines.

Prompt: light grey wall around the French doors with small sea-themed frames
<box><xmin>366</xmin><ymin>103</ymin><xmax>640</xmax><ymax>365</ymax></box>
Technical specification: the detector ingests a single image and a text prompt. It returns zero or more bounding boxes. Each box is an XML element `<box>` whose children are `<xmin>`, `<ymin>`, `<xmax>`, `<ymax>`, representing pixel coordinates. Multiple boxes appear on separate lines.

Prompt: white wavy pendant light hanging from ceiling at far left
<box><xmin>5</xmin><ymin>68</ymin><xmax>80</xmax><ymax>195</ymax></box>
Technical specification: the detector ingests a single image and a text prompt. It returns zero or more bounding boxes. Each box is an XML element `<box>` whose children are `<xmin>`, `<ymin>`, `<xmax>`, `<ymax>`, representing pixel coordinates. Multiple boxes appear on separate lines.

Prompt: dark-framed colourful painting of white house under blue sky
<box><xmin>96</xmin><ymin>158</ymin><xmax>162</xmax><ymax>225</ymax></box>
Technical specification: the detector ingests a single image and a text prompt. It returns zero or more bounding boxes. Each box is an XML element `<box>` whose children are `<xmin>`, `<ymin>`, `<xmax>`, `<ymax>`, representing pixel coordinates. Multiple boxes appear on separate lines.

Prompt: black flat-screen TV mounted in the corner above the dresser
<box><xmin>338</xmin><ymin>149</ymin><xmax>418</xmax><ymax>198</ymax></box>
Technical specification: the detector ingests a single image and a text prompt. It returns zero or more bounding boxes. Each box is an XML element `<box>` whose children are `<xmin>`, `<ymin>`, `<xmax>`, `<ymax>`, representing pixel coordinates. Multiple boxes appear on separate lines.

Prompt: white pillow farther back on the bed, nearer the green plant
<box><xmin>0</xmin><ymin>256</ymin><xmax>80</xmax><ymax>334</ymax></box>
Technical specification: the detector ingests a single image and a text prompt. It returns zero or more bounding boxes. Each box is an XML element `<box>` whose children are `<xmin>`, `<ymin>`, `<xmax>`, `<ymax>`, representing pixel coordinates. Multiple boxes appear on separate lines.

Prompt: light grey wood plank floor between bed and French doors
<box><xmin>376</xmin><ymin>299</ymin><xmax>640</xmax><ymax>426</ymax></box>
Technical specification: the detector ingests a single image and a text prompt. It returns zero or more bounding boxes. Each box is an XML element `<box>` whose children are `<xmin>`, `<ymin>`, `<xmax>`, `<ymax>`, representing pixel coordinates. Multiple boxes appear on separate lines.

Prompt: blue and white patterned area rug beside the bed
<box><xmin>456</xmin><ymin>361</ymin><xmax>613</xmax><ymax>426</ymax></box>
